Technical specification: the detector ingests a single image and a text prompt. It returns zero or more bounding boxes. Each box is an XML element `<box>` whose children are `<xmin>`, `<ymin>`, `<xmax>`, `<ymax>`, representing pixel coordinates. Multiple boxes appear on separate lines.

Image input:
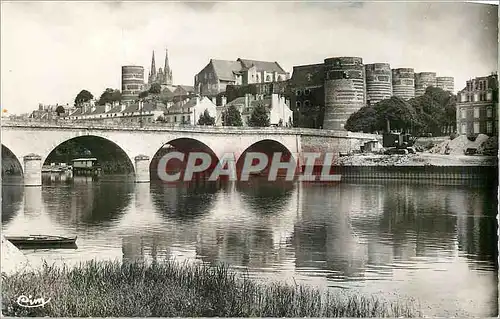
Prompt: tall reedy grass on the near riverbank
<box><xmin>2</xmin><ymin>261</ymin><xmax>420</xmax><ymax>317</ymax></box>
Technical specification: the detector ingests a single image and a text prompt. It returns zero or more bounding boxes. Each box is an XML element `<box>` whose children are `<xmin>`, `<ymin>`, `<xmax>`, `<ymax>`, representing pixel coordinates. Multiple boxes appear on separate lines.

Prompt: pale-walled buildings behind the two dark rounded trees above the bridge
<box><xmin>215</xmin><ymin>93</ymin><xmax>293</xmax><ymax>126</ymax></box>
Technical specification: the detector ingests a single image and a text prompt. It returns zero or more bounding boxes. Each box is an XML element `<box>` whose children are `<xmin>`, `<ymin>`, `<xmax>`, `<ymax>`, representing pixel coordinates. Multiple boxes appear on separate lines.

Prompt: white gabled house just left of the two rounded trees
<box><xmin>165</xmin><ymin>96</ymin><xmax>216</xmax><ymax>125</ymax></box>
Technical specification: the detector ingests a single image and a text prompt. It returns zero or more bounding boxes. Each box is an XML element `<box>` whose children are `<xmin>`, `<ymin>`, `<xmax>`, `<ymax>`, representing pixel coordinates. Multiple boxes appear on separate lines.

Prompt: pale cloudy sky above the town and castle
<box><xmin>0</xmin><ymin>1</ymin><xmax>498</xmax><ymax>114</ymax></box>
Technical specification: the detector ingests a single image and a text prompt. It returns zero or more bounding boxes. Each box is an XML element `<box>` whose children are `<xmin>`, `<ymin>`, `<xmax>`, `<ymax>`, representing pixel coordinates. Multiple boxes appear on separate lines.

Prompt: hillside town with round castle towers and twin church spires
<box><xmin>2</xmin><ymin>49</ymin><xmax>498</xmax><ymax>145</ymax></box>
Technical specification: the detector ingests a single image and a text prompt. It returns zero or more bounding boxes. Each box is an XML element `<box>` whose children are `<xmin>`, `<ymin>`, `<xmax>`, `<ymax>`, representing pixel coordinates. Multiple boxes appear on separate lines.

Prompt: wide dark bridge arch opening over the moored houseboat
<box><xmin>41</xmin><ymin>134</ymin><xmax>135</xmax><ymax>178</ymax></box>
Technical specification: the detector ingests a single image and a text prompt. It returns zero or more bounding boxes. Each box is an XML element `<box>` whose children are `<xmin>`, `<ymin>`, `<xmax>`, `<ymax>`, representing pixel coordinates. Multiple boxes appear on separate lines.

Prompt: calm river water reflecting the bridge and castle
<box><xmin>2</xmin><ymin>176</ymin><xmax>498</xmax><ymax>316</ymax></box>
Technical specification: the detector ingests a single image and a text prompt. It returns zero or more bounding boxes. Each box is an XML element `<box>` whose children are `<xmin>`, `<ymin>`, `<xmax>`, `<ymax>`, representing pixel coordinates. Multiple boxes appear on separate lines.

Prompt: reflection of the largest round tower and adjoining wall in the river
<box><xmin>294</xmin><ymin>184</ymin><xmax>366</xmax><ymax>281</ymax></box>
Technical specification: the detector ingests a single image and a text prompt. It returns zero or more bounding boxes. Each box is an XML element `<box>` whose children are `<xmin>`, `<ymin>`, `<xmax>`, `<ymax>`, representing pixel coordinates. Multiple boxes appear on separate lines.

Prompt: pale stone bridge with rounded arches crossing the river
<box><xmin>1</xmin><ymin>120</ymin><xmax>379</xmax><ymax>186</ymax></box>
